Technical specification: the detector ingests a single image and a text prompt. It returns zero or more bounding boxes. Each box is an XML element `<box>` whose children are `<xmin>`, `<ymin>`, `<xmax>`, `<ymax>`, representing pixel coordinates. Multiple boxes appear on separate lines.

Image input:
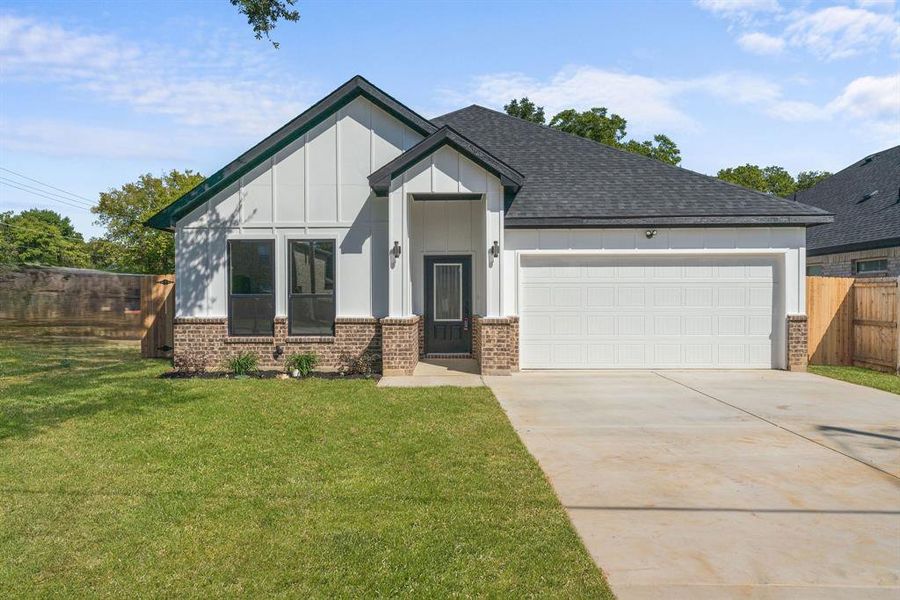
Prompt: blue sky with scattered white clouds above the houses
<box><xmin>0</xmin><ymin>0</ymin><xmax>900</xmax><ymax>237</ymax></box>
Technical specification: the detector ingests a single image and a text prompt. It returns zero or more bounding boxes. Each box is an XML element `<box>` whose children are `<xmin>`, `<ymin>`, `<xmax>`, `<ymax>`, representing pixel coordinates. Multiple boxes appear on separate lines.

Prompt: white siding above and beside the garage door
<box><xmin>503</xmin><ymin>227</ymin><xmax>806</xmax><ymax>315</ymax></box>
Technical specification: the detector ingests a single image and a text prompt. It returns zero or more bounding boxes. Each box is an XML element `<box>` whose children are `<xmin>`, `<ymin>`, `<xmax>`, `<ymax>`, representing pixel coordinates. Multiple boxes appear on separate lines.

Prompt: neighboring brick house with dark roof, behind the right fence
<box><xmin>796</xmin><ymin>146</ymin><xmax>900</xmax><ymax>277</ymax></box>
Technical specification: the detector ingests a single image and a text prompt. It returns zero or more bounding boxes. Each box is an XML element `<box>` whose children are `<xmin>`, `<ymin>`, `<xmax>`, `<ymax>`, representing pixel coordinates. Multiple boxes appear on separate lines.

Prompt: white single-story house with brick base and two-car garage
<box><xmin>148</xmin><ymin>77</ymin><xmax>831</xmax><ymax>374</ymax></box>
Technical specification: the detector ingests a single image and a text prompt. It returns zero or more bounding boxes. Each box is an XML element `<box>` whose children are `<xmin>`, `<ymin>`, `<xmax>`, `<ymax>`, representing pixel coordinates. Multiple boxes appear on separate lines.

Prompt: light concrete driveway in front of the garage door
<box><xmin>485</xmin><ymin>371</ymin><xmax>900</xmax><ymax>600</ymax></box>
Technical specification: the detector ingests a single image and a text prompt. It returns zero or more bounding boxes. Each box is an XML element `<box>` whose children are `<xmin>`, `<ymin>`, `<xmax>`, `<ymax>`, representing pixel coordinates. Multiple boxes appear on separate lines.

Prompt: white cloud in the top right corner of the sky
<box><xmin>785</xmin><ymin>6</ymin><xmax>900</xmax><ymax>60</ymax></box>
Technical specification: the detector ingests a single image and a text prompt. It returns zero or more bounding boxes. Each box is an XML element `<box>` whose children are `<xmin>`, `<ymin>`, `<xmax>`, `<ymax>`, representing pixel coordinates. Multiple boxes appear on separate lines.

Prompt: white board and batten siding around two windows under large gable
<box><xmin>175</xmin><ymin>98</ymin><xmax>422</xmax><ymax>317</ymax></box>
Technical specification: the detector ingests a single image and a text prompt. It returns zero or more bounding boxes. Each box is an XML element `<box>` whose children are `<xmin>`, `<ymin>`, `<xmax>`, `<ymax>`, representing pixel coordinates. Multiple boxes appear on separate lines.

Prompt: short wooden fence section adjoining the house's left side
<box><xmin>141</xmin><ymin>275</ymin><xmax>175</xmax><ymax>358</ymax></box>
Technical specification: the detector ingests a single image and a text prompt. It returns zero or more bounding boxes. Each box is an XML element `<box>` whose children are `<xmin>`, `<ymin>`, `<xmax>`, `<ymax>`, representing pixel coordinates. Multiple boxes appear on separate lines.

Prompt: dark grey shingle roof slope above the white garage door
<box><xmin>431</xmin><ymin>105</ymin><xmax>831</xmax><ymax>227</ymax></box>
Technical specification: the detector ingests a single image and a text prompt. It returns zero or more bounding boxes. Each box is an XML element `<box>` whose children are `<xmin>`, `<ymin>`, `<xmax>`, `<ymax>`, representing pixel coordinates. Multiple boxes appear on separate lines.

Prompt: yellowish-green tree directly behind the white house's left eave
<box><xmin>91</xmin><ymin>170</ymin><xmax>203</xmax><ymax>273</ymax></box>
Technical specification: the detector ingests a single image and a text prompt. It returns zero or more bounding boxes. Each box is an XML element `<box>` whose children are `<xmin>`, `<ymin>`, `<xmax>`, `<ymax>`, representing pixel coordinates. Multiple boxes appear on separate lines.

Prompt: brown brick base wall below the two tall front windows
<box><xmin>174</xmin><ymin>317</ymin><xmax>381</xmax><ymax>370</ymax></box>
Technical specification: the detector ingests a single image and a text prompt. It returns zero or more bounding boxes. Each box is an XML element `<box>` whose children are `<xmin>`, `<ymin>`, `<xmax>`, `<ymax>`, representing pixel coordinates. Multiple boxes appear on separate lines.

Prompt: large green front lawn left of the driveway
<box><xmin>0</xmin><ymin>339</ymin><xmax>612</xmax><ymax>598</ymax></box>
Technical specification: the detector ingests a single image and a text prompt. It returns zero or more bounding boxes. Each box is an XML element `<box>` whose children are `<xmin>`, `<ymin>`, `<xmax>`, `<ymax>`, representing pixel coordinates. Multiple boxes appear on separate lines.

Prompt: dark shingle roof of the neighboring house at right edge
<box><xmin>797</xmin><ymin>146</ymin><xmax>900</xmax><ymax>255</ymax></box>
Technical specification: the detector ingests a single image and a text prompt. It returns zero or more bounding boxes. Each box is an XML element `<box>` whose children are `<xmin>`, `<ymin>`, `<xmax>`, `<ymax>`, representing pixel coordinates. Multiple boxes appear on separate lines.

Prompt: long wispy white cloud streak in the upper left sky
<box><xmin>0</xmin><ymin>15</ymin><xmax>312</xmax><ymax>139</ymax></box>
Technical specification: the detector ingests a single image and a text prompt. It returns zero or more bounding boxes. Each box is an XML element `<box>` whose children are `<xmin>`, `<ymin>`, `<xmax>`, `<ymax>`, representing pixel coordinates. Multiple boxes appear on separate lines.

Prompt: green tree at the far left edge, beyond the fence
<box><xmin>0</xmin><ymin>208</ymin><xmax>91</xmax><ymax>267</ymax></box>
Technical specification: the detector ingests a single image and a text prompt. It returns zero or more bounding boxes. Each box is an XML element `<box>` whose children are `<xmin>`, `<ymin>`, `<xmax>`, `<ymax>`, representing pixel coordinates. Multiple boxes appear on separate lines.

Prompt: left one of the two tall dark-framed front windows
<box><xmin>228</xmin><ymin>240</ymin><xmax>275</xmax><ymax>336</ymax></box>
